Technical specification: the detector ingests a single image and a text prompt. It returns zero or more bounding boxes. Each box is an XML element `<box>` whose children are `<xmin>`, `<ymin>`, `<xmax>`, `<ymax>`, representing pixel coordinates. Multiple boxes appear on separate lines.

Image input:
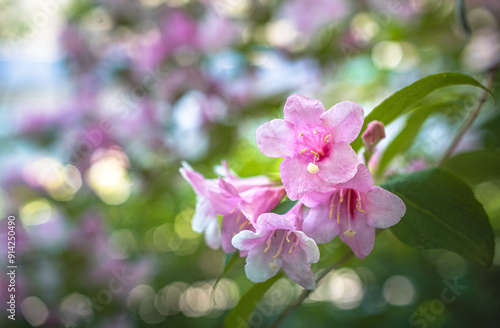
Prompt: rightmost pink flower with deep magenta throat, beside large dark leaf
<box><xmin>303</xmin><ymin>164</ymin><xmax>406</xmax><ymax>258</ymax></box>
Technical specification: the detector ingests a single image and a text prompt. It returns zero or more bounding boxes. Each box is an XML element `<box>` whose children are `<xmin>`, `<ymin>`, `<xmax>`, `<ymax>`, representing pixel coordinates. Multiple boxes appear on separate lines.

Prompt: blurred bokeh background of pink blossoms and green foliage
<box><xmin>0</xmin><ymin>0</ymin><xmax>500</xmax><ymax>328</ymax></box>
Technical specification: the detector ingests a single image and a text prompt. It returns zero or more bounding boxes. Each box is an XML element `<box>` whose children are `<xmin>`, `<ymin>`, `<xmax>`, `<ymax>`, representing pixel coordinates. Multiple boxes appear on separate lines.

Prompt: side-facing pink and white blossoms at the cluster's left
<box><xmin>180</xmin><ymin>162</ymin><xmax>285</xmax><ymax>253</ymax></box>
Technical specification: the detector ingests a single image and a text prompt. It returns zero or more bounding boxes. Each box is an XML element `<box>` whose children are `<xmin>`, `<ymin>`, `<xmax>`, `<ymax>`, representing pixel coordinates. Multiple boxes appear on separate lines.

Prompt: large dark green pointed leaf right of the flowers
<box><xmin>383</xmin><ymin>168</ymin><xmax>495</xmax><ymax>266</ymax></box>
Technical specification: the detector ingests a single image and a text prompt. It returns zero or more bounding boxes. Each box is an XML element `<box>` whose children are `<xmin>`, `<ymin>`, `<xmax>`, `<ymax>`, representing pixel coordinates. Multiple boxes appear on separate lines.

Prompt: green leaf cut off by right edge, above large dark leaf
<box><xmin>443</xmin><ymin>150</ymin><xmax>500</xmax><ymax>185</ymax></box>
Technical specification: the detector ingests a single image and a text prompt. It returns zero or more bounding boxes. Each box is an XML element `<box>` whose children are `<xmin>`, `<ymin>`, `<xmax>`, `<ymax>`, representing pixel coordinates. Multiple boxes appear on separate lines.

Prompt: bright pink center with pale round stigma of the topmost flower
<box><xmin>296</xmin><ymin>129</ymin><xmax>332</xmax><ymax>174</ymax></box>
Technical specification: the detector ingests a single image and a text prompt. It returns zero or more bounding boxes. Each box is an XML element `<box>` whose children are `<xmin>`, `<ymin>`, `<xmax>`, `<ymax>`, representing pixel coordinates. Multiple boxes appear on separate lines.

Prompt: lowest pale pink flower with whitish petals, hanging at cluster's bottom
<box><xmin>232</xmin><ymin>203</ymin><xmax>319</xmax><ymax>289</ymax></box>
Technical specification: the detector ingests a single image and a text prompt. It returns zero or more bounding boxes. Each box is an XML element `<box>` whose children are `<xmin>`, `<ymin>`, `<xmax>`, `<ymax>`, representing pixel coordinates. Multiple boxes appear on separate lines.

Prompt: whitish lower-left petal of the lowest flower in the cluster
<box><xmin>245</xmin><ymin>242</ymin><xmax>282</xmax><ymax>283</ymax></box>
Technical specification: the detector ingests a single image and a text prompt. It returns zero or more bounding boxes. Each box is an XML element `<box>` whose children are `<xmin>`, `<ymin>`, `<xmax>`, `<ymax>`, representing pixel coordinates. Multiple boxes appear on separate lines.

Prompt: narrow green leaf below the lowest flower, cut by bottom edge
<box><xmin>224</xmin><ymin>273</ymin><xmax>283</xmax><ymax>328</ymax></box>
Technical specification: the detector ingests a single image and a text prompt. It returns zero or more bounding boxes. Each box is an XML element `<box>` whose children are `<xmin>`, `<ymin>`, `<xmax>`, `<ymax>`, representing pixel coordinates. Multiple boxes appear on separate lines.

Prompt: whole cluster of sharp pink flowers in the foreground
<box><xmin>181</xmin><ymin>94</ymin><xmax>406</xmax><ymax>289</ymax></box>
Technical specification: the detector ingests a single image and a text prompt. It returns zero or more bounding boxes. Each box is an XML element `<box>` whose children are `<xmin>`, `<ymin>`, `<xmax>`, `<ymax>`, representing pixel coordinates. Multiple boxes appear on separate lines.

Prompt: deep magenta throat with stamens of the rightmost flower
<box><xmin>330</xmin><ymin>189</ymin><xmax>366</xmax><ymax>237</ymax></box>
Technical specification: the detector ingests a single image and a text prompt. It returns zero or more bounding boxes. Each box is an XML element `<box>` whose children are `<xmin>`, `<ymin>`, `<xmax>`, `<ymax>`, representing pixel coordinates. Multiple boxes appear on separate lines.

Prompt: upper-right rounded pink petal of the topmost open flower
<box><xmin>321</xmin><ymin>101</ymin><xmax>364</xmax><ymax>143</ymax></box>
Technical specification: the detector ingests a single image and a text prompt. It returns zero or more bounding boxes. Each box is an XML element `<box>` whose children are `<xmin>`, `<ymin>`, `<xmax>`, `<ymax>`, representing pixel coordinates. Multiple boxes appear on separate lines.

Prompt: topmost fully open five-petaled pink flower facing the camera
<box><xmin>256</xmin><ymin>94</ymin><xmax>364</xmax><ymax>200</ymax></box>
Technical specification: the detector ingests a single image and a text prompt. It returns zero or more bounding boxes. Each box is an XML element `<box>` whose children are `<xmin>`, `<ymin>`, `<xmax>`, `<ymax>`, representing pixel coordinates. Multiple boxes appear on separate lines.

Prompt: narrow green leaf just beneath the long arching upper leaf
<box><xmin>377</xmin><ymin>103</ymin><xmax>456</xmax><ymax>175</ymax></box>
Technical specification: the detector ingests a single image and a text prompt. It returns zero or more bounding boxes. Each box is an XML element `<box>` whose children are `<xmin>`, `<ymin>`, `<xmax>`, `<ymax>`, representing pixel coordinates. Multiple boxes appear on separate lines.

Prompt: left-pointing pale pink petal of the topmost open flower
<box><xmin>255</xmin><ymin>119</ymin><xmax>298</xmax><ymax>157</ymax></box>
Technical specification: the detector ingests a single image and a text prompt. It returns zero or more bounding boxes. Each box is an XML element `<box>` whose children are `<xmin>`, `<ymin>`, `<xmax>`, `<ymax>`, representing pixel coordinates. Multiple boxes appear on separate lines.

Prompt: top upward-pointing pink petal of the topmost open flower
<box><xmin>284</xmin><ymin>93</ymin><xmax>325</xmax><ymax>126</ymax></box>
